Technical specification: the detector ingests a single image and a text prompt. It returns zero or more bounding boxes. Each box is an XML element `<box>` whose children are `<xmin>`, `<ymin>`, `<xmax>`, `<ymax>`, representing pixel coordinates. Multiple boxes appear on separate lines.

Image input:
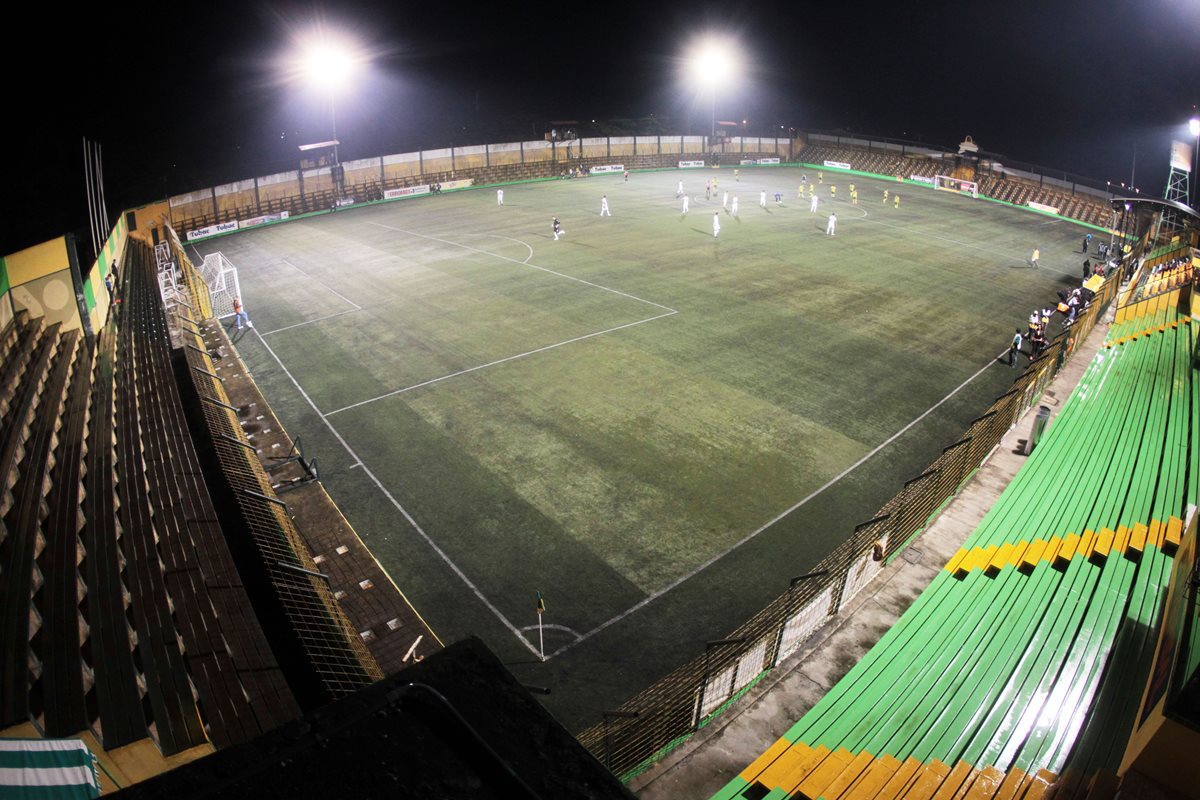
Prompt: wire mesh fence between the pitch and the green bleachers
<box><xmin>580</xmin><ymin>275</ymin><xmax>1120</xmax><ymax>781</ymax></box>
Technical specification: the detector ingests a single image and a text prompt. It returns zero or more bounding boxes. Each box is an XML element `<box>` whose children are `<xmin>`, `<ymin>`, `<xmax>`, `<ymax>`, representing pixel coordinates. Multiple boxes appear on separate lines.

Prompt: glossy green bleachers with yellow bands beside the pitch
<box><xmin>714</xmin><ymin>272</ymin><xmax>1200</xmax><ymax>800</ymax></box>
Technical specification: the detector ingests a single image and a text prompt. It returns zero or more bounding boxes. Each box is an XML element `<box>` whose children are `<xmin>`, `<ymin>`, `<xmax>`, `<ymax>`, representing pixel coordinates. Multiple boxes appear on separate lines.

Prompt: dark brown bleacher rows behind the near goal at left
<box><xmin>0</xmin><ymin>239</ymin><xmax>378</xmax><ymax>756</ymax></box>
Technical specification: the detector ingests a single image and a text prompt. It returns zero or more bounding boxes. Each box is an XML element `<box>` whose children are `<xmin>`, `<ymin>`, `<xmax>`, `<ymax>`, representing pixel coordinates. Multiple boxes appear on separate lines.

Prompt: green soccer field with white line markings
<box><xmin>196</xmin><ymin>168</ymin><xmax>1099</xmax><ymax>730</ymax></box>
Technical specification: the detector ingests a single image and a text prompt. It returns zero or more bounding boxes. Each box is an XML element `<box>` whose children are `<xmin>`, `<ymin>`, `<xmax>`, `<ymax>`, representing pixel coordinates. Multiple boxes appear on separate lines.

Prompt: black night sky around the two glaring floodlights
<box><xmin>0</xmin><ymin>0</ymin><xmax>1200</xmax><ymax>259</ymax></box>
